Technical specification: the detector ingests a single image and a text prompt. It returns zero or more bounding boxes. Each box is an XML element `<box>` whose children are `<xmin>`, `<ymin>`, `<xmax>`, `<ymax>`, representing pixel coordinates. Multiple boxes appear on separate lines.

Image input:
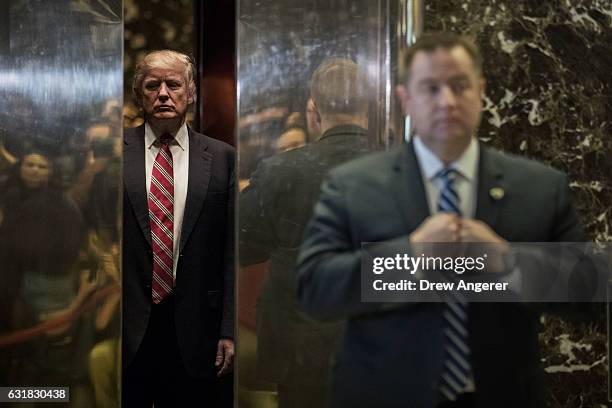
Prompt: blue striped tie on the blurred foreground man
<box><xmin>437</xmin><ymin>168</ymin><xmax>471</xmax><ymax>401</ymax></box>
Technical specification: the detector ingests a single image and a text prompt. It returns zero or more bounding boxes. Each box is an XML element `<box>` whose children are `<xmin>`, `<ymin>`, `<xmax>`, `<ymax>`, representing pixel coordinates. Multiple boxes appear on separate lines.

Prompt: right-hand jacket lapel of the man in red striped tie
<box><xmin>179</xmin><ymin>129</ymin><xmax>213</xmax><ymax>252</ymax></box>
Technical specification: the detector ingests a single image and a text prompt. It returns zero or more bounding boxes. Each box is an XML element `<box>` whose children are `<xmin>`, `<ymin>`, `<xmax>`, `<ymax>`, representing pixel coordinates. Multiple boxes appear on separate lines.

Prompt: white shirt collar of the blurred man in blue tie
<box><xmin>414</xmin><ymin>136</ymin><xmax>480</xmax><ymax>182</ymax></box>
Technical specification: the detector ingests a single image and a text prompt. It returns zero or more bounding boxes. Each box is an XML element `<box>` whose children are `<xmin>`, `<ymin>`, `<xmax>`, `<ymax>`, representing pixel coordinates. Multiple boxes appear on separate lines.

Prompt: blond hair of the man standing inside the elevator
<box><xmin>132</xmin><ymin>50</ymin><xmax>196</xmax><ymax>106</ymax></box>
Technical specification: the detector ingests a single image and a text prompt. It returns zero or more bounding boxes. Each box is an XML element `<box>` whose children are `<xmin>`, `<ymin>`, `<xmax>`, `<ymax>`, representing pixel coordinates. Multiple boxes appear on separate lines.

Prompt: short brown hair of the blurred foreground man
<box><xmin>400</xmin><ymin>32</ymin><xmax>482</xmax><ymax>84</ymax></box>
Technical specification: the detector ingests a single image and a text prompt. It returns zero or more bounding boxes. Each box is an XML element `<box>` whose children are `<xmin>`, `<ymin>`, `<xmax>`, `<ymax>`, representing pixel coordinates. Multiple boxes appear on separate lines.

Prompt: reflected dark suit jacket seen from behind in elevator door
<box><xmin>239</xmin><ymin>125</ymin><xmax>370</xmax><ymax>385</ymax></box>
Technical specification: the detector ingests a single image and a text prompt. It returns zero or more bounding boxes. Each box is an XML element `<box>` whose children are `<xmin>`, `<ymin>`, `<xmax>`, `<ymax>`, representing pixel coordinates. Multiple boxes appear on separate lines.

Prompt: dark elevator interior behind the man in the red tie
<box><xmin>124</xmin><ymin>0</ymin><xmax>236</xmax><ymax>408</ymax></box>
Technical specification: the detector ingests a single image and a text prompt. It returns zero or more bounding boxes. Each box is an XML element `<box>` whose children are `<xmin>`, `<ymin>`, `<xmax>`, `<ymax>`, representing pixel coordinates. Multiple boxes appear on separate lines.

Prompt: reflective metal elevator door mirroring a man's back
<box><xmin>236</xmin><ymin>0</ymin><xmax>405</xmax><ymax>408</ymax></box>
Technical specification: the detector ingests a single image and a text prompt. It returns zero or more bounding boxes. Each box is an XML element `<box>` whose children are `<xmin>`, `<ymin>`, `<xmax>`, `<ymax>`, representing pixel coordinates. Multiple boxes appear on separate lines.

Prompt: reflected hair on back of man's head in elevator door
<box><xmin>310</xmin><ymin>58</ymin><xmax>368</xmax><ymax>115</ymax></box>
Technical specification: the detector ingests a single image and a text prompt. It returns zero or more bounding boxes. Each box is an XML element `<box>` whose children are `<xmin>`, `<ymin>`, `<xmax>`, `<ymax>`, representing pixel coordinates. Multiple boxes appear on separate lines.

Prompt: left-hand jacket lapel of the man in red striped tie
<box><xmin>123</xmin><ymin>125</ymin><xmax>151</xmax><ymax>245</ymax></box>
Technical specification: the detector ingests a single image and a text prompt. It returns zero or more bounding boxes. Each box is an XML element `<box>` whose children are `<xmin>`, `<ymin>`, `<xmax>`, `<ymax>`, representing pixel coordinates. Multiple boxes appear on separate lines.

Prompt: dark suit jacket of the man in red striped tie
<box><xmin>123</xmin><ymin>125</ymin><xmax>235</xmax><ymax>378</ymax></box>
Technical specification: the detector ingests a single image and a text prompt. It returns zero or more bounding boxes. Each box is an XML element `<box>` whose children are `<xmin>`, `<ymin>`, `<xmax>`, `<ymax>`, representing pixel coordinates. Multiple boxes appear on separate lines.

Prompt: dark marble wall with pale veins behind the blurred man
<box><xmin>425</xmin><ymin>0</ymin><xmax>612</xmax><ymax>408</ymax></box>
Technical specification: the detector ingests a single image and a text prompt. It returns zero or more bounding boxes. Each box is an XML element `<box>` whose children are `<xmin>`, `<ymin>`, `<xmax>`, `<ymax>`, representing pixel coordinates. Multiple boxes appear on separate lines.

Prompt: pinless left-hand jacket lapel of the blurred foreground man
<box><xmin>389</xmin><ymin>143</ymin><xmax>429</xmax><ymax>232</ymax></box>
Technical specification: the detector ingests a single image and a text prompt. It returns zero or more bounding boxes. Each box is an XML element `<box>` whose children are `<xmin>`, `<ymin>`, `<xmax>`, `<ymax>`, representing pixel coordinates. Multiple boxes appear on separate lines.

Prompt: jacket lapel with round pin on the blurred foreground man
<box><xmin>475</xmin><ymin>143</ymin><xmax>508</xmax><ymax>230</ymax></box>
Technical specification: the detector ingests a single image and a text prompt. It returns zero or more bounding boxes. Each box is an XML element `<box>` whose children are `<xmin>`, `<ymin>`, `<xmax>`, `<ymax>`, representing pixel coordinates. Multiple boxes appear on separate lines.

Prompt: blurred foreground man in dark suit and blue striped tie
<box><xmin>298</xmin><ymin>34</ymin><xmax>582</xmax><ymax>408</ymax></box>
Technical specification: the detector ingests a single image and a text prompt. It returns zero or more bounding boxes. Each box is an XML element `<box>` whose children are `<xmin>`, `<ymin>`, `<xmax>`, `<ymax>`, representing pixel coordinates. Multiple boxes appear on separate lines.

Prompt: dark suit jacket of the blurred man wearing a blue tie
<box><xmin>298</xmin><ymin>144</ymin><xmax>583</xmax><ymax>408</ymax></box>
